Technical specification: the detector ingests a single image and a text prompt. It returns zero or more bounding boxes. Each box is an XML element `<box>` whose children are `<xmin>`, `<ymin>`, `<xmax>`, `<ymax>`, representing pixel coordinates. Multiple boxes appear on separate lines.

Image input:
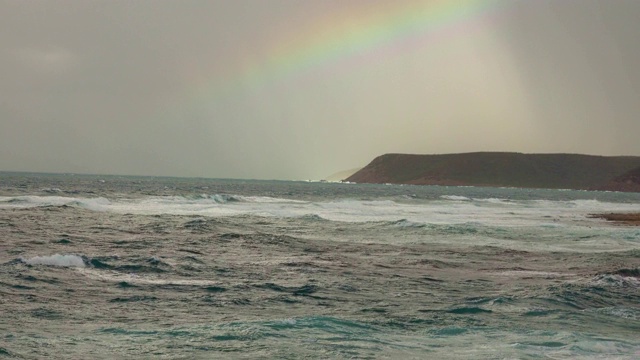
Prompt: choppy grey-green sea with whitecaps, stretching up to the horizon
<box><xmin>0</xmin><ymin>173</ymin><xmax>640</xmax><ymax>359</ymax></box>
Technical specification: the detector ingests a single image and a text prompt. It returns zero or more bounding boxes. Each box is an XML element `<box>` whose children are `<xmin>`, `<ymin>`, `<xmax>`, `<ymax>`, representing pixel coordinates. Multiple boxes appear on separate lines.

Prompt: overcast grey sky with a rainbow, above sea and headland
<box><xmin>0</xmin><ymin>0</ymin><xmax>640</xmax><ymax>180</ymax></box>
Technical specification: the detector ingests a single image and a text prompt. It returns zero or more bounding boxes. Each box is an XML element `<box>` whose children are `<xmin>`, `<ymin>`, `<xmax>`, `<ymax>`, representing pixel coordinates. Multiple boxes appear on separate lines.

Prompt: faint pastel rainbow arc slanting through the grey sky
<box><xmin>184</xmin><ymin>0</ymin><xmax>510</xmax><ymax>106</ymax></box>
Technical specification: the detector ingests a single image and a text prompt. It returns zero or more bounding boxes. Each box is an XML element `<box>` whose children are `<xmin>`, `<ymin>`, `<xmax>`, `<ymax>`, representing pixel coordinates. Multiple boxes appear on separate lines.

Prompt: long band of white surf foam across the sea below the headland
<box><xmin>0</xmin><ymin>194</ymin><xmax>640</xmax><ymax>227</ymax></box>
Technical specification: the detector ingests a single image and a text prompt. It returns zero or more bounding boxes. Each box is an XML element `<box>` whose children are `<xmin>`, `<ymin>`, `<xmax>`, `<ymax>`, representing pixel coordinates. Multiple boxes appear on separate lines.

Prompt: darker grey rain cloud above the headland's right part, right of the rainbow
<box><xmin>503</xmin><ymin>0</ymin><xmax>640</xmax><ymax>155</ymax></box>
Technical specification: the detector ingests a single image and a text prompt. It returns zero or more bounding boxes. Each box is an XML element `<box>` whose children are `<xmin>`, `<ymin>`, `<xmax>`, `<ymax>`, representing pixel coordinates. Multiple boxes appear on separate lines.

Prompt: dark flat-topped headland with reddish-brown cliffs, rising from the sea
<box><xmin>346</xmin><ymin>152</ymin><xmax>640</xmax><ymax>191</ymax></box>
